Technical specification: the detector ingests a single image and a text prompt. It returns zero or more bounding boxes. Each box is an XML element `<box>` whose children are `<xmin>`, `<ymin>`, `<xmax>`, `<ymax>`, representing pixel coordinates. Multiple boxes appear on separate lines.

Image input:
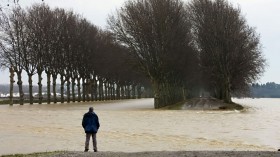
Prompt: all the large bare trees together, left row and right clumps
<box><xmin>0</xmin><ymin>0</ymin><xmax>265</xmax><ymax>108</ymax></box>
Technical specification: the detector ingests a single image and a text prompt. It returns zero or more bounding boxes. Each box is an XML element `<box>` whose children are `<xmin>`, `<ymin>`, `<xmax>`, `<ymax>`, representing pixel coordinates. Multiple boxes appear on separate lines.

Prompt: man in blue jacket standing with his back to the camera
<box><xmin>82</xmin><ymin>107</ymin><xmax>100</xmax><ymax>152</ymax></box>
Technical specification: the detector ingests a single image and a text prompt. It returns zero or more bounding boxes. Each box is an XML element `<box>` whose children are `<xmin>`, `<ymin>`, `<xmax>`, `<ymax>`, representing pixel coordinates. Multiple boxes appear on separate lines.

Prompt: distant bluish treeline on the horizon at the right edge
<box><xmin>250</xmin><ymin>82</ymin><xmax>280</xmax><ymax>98</ymax></box>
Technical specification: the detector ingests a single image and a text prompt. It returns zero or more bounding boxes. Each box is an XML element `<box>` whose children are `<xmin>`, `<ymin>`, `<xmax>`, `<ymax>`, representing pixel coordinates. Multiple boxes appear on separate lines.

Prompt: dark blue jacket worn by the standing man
<box><xmin>82</xmin><ymin>112</ymin><xmax>100</xmax><ymax>133</ymax></box>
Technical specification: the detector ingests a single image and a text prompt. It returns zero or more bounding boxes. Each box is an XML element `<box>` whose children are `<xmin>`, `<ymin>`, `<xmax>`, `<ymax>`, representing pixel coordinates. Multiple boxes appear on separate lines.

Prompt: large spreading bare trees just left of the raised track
<box><xmin>108</xmin><ymin>0</ymin><xmax>196</xmax><ymax>108</ymax></box>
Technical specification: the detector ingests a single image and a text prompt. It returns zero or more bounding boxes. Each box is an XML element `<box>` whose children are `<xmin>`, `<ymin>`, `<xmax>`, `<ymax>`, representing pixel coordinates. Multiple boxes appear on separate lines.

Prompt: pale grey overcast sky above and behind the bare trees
<box><xmin>0</xmin><ymin>0</ymin><xmax>280</xmax><ymax>84</ymax></box>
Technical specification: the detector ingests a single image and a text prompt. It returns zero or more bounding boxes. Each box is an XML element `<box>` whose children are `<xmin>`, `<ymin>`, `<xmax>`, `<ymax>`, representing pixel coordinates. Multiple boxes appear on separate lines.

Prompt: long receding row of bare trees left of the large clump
<box><xmin>0</xmin><ymin>4</ymin><xmax>150</xmax><ymax>104</ymax></box>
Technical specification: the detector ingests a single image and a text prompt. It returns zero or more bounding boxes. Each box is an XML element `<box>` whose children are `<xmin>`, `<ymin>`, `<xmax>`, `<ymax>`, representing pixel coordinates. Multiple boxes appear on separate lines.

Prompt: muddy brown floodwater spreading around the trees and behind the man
<box><xmin>0</xmin><ymin>99</ymin><xmax>280</xmax><ymax>155</ymax></box>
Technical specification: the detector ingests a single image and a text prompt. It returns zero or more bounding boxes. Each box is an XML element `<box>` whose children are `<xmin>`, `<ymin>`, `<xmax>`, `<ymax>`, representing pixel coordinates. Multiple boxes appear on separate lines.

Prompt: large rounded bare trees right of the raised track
<box><xmin>188</xmin><ymin>0</ymin><xmax>265</xmax><ymax>102</ymax></box>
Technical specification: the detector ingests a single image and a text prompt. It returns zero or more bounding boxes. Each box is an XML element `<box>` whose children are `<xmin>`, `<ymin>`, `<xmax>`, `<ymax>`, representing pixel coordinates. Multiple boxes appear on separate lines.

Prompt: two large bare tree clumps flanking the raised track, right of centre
<box><xmin>108</xmin><ymin>0</ymin><xmax>265</xmax><ymax>108</ymax></box>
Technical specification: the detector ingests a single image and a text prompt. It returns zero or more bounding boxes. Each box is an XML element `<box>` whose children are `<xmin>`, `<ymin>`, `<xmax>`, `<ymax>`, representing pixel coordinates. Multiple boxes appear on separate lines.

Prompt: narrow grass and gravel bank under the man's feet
<box><xmin>2</xmin><ymin>151</ymin><xmax>280</xmax><ymax>157</ymax></box>
